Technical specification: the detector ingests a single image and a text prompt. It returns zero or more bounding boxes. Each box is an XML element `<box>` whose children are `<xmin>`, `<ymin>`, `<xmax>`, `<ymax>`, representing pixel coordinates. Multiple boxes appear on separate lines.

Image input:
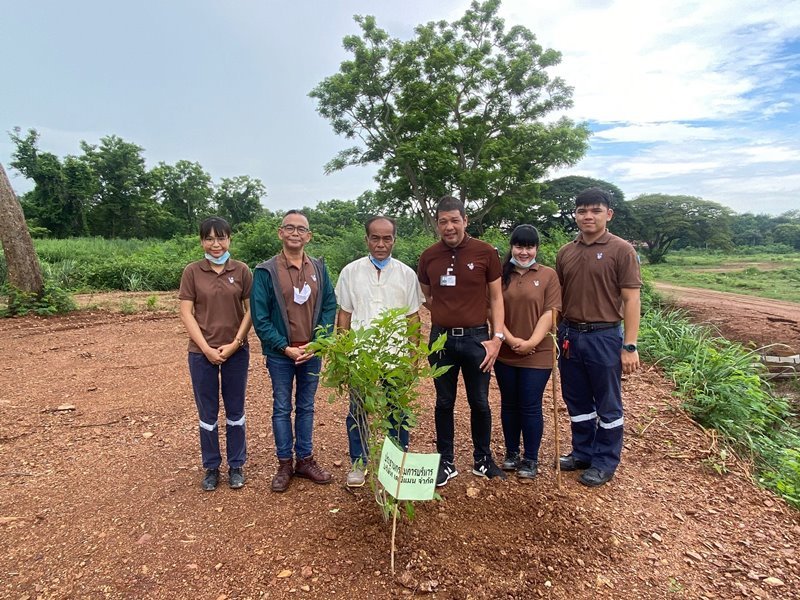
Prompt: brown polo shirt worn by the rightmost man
<box><xmin>556</xmin><ymin>230</ymin><xmax>642</xmax><ymax>323</ymax></box>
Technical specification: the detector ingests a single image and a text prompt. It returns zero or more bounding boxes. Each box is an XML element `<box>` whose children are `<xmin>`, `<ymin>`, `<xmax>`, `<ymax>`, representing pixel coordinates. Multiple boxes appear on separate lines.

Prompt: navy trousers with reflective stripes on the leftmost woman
<box><xmin>189</xmin><ymin>346</ymin><xmax>250</xmax><ymax>469</ymax></box>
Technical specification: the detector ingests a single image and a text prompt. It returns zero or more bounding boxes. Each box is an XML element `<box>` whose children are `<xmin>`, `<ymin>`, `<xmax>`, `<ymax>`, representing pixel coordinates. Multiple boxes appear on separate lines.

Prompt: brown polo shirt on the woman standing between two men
<box><xmin>497</xmin><ymin>264</ymin><xmax>561</xmax><ymax>369</ymax></box>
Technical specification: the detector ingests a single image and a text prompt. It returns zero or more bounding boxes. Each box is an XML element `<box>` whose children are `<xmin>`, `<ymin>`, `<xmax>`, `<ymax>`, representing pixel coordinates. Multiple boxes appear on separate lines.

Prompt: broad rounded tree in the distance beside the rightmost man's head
<box><xmin>610</xmin><ymin>194</ymin><xmax>732</xmax><ymax>264</ymax></box>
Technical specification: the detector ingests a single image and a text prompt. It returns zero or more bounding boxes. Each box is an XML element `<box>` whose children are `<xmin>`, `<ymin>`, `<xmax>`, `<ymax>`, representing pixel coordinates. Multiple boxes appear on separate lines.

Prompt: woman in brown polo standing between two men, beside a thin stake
<box><xmin>494</xmin><ymin>225</ymin><xmax>561</xmax><ymax>479</ymax></box>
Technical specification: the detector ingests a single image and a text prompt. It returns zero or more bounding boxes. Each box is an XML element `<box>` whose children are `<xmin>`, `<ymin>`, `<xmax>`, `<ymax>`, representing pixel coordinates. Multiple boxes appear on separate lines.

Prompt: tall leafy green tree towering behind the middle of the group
<box><xmin>310</xmin><ymin>0</ymin><xmax>589</xmax><ymax>230</ymax></box>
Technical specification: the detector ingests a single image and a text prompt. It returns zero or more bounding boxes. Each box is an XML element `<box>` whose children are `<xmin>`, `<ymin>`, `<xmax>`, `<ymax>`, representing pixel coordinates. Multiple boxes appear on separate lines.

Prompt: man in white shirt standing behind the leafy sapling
<box><xmin>336</xmin><ymin>216</ymin><xmax>424</xmax><ymax>487</ymax></box>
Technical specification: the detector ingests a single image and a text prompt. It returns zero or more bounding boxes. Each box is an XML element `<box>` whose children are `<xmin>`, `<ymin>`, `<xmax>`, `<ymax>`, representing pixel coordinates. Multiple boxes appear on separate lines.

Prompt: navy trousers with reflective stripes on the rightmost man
<box><xmin>558</xmin><ymin>323</ymin><xmax>623</xmax><ymax>473</ymax></box>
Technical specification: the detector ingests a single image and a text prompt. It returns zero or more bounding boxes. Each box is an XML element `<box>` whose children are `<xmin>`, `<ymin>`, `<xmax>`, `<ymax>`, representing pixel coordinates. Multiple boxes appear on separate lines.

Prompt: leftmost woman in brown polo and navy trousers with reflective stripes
<box><xmin>178</xmin><ymin>217</ymin><xmax>253</xmax><ymax>491</ymax></box>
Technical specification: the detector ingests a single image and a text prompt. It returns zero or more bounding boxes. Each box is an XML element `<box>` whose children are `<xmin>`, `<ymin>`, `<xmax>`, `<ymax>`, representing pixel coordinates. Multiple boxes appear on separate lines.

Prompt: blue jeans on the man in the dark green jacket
<box><xmin>267</xmin><ymin>356</ymin><xmax>322</xmax><ymax>459</ymax></box>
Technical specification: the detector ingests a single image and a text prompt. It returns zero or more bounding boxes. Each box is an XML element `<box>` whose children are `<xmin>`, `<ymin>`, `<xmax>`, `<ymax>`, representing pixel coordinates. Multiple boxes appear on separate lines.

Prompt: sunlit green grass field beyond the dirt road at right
<box><xmin>644</xmin><ymin>252</ymin><xmax>800</xmax><ymax>303</ymax></box>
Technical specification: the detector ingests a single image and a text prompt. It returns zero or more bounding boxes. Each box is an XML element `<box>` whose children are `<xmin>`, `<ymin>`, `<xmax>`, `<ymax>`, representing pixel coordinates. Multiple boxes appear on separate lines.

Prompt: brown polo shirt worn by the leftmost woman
<box><xmin>178</xmin><ymin>258</ymin><xmax>253</xmax><ymax>354</ymax></box>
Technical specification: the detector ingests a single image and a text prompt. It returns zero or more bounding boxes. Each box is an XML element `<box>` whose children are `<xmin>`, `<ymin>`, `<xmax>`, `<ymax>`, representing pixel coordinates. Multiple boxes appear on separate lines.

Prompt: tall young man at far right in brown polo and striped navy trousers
<box><xmin>556</xmin><ymin>188</ymin><xmax>642</xmax><ymax>487</ymax></box>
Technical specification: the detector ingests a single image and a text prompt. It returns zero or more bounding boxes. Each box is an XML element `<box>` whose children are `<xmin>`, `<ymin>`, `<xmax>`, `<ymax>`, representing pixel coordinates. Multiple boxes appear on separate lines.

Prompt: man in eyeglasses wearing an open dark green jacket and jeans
<box><xmin>250</xmin><ymin>210</ymin><xmax>336</xmax><ymax>492</ymax></box>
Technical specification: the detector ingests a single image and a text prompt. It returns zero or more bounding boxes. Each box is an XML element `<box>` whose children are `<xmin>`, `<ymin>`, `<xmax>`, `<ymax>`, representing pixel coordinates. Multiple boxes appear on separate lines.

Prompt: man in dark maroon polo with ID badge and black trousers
<box><xmin>417</xmin><ymin>196</ymin><xmax>506</xmax><ymax>487</ymax></box>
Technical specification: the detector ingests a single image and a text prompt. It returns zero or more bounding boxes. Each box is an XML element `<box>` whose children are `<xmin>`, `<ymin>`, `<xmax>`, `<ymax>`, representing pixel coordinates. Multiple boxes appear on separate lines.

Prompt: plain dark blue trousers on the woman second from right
<box><xmin>494</xmin><ymin>361</ymin><xmax>550</xmax><ymax>461</ymax></box>
